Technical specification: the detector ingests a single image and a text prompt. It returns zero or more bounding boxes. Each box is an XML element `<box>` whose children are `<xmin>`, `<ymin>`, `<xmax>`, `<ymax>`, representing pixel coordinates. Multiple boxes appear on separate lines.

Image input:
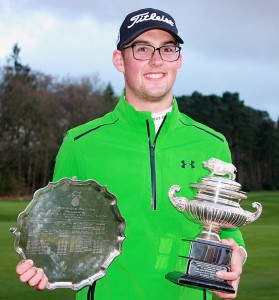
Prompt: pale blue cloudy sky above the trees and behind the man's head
<box><xmin>0</xmin><ymin>0</ymin><xmax>279</xmax><ymax>121</ymax></box>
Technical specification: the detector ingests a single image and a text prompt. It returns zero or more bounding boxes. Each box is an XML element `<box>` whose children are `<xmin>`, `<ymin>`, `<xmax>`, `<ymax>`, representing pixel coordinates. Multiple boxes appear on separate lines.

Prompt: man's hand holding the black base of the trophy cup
<box><xmin>213</xmin><ymin>239</ymin><xmax>246</xmax><ymax>299</ymax></box>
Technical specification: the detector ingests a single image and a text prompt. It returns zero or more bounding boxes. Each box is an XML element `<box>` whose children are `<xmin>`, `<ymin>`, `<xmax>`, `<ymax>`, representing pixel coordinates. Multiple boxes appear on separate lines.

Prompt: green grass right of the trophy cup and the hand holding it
<box><xmin>232</xmin><ymin>192</ymin><xmax>279</xmax><ymax>300</ymax></box>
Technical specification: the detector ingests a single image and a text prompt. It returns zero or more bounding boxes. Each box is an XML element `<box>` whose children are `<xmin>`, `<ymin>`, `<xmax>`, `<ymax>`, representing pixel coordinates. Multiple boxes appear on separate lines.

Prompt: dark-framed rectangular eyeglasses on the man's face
<box><xmin>122</xmin><ymin>43</ymin><xmax>181</xmax><ymax>61</ymax></box>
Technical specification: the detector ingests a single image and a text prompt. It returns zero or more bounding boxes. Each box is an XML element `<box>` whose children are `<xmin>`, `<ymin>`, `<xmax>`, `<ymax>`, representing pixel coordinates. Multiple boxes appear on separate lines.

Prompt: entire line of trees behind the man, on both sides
<box><xmin>0</xmin><ymin>45</ymin><xmax>279</xmax><ymax>196</ymax></box>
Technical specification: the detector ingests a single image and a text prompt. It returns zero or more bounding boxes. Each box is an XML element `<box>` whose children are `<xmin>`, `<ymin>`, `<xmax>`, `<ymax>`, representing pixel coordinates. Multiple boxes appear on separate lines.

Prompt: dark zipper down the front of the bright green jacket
<box><xmin>146</xmin><ymin>115</ymin><xmax>167</xmax><ymax>210</ymax></box>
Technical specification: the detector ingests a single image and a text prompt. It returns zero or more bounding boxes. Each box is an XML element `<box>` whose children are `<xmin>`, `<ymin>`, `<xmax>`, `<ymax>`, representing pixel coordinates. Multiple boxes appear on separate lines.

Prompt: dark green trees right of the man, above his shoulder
<box><xmin>178</xmin><ymin>92</ymin><xmax>279</xmax><ymax>191</ymax></box>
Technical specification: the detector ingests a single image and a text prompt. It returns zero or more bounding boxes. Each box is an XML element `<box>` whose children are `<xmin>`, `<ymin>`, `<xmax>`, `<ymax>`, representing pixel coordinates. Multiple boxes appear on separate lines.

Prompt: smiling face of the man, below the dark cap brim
<box><xmin>114</xmin><ymin>29</ymin><xmax>182</xmax><ymax>106</ymax></box>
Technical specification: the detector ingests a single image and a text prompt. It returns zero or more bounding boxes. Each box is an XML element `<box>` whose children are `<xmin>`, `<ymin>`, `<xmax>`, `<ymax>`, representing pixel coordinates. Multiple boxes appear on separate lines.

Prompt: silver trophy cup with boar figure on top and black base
<box><xmin>166</xmin><ymin>158</ymin><xmax>262</xmax><ymax>293</ymax></box>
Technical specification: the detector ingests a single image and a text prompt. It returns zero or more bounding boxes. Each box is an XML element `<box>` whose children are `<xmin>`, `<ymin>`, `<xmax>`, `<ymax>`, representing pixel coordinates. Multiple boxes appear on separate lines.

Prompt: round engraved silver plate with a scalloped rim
<box><xmin>11</xmin><ymin>178</ymin><xmax>125</xmax><ymax>290</ymax></box>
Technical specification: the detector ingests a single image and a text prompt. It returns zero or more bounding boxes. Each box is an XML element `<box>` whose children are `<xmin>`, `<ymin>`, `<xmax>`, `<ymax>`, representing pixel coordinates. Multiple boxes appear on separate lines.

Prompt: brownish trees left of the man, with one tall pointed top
<box><xmin>0</xmin><ymin>44</ymin><xmax>116</xmax><ymax>195</ymax></box>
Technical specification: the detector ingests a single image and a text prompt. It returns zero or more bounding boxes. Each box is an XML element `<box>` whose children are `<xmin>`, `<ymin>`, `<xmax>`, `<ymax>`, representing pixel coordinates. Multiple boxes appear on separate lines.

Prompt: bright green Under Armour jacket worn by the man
<box><xmin>54</xmin><ymin>95</ymin><xmax>244</xmax><ymax>300</ymax></box>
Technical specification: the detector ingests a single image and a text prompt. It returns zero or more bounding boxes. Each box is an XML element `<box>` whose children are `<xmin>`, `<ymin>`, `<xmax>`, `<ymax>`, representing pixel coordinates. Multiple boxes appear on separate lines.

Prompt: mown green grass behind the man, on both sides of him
<box><xmin>0</xmin><ymin>192</ymin><xmax>279</xmax><ymax>300</ymax></box>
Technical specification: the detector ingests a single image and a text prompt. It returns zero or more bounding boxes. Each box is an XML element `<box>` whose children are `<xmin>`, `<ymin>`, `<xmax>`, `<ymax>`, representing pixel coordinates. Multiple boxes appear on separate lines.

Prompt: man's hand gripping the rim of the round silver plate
<box><xmin>16</xmin><ymin>259</ymin><xmax>48</xmax><ymax>291</ymax></box>
